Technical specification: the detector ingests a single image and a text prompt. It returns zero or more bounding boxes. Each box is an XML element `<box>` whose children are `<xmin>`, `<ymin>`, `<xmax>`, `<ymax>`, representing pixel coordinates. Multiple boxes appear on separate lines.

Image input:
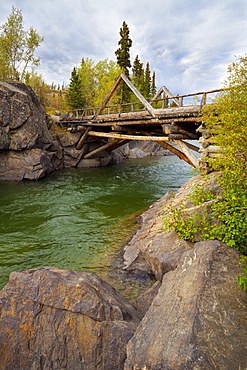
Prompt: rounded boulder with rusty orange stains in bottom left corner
<box><xmin>0</xmin><ymin>267</ymin><xmax>140</xmax><ymax>370</ymax></box>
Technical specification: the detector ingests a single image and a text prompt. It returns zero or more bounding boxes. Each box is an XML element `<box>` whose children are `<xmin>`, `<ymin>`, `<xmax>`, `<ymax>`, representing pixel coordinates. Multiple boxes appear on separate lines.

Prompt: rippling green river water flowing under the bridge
<box><xmin>0</xmin><ymin>156</ymin><xmax>192</xmax><ymax>297</ymax></box>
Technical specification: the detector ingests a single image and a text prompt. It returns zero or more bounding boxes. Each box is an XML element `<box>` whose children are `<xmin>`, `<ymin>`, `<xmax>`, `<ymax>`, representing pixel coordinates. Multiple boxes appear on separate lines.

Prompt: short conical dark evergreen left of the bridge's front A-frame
<box><xmin>66</xmin><ymin>67</ymin><xmax>85</xmax><ymax>109</ymax></box>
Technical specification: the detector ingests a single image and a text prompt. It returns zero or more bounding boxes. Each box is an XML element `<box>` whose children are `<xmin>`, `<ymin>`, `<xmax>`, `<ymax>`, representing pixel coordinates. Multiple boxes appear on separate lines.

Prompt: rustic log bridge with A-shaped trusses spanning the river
<box><xmin>60</xmin><ymin>73</ymin><xmax>221</xmax><ymax>168</ymax></box>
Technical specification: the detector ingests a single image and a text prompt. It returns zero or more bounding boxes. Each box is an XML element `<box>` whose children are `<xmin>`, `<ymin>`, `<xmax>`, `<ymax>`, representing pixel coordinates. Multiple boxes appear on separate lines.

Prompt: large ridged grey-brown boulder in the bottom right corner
<box><xmin>124</xmin><ymin>241</ymin><xmax>247</xmax><ymax>370</ymax></box>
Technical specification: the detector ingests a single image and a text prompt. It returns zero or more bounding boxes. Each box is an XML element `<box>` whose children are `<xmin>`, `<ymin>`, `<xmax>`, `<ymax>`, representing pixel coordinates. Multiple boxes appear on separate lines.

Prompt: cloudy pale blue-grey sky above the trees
<box><xmin>0</xmin><ymin>0</ymin><xmax>247</xmax><ymax>94</ymax></box>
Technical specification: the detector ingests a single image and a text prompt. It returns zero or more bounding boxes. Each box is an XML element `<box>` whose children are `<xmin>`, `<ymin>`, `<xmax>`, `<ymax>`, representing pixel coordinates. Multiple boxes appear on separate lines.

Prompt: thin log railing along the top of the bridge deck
<box><xmin>68</xmin><ymin>89</ymin><xmax>222</xmax><ymax>119</ymax></box>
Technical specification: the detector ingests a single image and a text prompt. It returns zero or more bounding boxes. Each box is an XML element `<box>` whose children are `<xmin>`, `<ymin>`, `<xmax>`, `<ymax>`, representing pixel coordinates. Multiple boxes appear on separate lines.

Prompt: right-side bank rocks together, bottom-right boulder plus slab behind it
<box><xmin>123</xmin><ymin>173</ymin><xmax>247</xmax><ymax>370</ymax></box>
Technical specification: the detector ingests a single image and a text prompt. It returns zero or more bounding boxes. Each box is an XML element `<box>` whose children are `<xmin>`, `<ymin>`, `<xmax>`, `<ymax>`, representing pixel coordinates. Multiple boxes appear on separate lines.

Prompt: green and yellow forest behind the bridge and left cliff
<box><xmin>0</xmin><ymin>6</ymin><xmax>156</xmax><ymax>114</ymax></box>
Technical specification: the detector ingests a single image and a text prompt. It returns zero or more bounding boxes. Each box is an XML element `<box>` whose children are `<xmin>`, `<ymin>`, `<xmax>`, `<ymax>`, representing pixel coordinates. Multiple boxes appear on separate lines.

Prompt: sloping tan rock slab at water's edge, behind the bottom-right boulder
<box><xmin>123</xmin><ymin>173</ymin><xmax>218</xmax><ymax>281</ymax></box>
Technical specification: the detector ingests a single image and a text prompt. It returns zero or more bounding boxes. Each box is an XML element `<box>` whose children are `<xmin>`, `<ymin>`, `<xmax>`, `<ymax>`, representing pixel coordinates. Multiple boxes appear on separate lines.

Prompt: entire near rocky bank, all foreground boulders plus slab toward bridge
<box><xmin>0</xmin><ymin>174</ymin><xmax>247</xmax><ymax>370</ymax></box>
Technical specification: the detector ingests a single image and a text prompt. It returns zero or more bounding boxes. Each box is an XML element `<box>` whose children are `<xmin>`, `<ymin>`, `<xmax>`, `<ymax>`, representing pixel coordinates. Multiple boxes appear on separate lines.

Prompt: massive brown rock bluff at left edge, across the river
<box><xmin>0</xmin><ymin>81</ymin><xmax>62</xmax><ymax>180</ymax></box>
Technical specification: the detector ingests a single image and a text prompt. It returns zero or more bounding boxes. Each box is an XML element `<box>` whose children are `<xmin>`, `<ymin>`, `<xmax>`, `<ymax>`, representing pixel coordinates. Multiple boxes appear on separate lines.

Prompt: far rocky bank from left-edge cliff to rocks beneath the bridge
<box><xmin>0</xmin><ymin>81</ymin><xmax>171</xmax><ymax>181</ymax></box>
